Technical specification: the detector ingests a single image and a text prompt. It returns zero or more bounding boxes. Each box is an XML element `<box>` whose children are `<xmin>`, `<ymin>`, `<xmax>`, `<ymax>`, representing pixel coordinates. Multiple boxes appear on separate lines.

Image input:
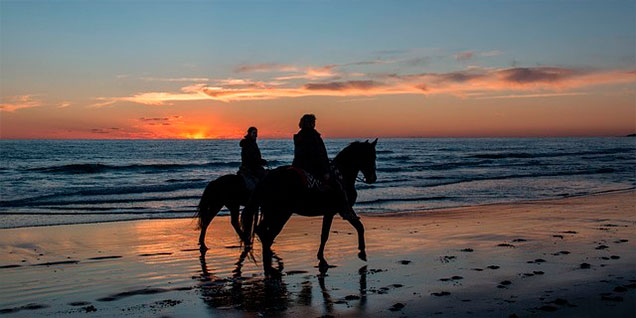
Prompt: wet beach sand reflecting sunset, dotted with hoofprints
<box><xmin>0</xmin><ymin>191</ymin><xmax>636</xmax><ymax>317</ymax></box>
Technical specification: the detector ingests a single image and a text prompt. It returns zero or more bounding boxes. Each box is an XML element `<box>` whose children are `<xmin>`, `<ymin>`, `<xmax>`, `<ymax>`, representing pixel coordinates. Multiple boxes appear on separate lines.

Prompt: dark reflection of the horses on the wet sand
<box><xmin>194</xmin><ymin>249</ymin><xmax>367</xmax><ymax>315</ymax></box>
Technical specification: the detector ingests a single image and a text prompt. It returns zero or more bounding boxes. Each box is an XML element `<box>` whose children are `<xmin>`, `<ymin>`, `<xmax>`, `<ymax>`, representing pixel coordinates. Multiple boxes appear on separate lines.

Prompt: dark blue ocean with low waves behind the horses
<box><xmin>0</xmin><ymin>137</ymin><xmax>636</xmax><ymax>228</ymax></box>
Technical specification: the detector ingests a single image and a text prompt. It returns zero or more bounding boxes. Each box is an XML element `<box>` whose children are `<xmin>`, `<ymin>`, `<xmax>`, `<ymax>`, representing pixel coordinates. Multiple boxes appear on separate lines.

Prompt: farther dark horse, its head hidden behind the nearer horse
<box><xmin>195</xmin><ymin>174</ymin><xmax>250</xmax><ymax>252</ymax></box>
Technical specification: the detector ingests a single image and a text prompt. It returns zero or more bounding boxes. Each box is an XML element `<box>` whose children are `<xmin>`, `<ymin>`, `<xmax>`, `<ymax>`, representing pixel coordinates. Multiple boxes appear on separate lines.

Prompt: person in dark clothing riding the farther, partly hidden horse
<box><xmin>238</xmin><ymin>127</ymin><xmax>267</xmax><ymax>192</ymax></box>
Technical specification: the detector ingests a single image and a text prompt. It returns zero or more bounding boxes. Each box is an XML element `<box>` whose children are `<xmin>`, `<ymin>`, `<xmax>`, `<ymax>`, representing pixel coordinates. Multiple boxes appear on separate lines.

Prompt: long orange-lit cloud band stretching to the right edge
<box><xmin>98</xmin><ymin>67</ymin><xmax>636</xmax><ymax>105</ymax></box>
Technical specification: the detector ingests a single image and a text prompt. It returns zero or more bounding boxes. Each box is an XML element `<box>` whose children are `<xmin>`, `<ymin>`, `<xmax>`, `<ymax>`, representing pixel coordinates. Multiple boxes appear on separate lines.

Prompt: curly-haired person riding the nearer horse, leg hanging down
<box><xmin>292</xmin><ymin>114</ymin><xmax>359</xmax><ymax>220</ymax></box>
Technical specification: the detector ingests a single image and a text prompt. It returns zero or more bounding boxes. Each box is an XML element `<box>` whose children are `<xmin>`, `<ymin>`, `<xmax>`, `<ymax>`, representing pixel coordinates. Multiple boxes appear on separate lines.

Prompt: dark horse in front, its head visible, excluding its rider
<box><xmin>241</xmin><ymin>139</ymin><xmax>378</xmax><ymax>273</ymax></box>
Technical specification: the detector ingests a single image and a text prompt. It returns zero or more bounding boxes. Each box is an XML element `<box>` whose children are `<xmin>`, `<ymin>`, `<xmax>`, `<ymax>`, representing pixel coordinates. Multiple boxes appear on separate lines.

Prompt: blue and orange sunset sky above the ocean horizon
<box><xmin>0</xmin><ymin>0</ymin><xmax>636</xmax><ymax>139</ymax></box>
